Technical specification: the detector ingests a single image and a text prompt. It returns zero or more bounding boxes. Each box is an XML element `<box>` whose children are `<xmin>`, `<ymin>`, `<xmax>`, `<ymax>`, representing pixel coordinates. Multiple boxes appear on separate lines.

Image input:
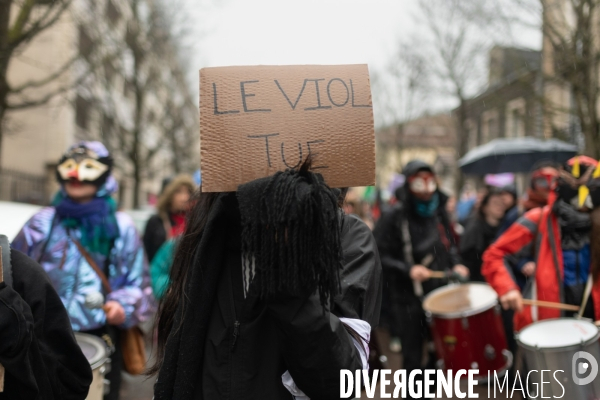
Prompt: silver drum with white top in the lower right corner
<box><xmin>517</xmin><ymin>318</ymin><xmax>600</xmax><ymax>400</ymax></box>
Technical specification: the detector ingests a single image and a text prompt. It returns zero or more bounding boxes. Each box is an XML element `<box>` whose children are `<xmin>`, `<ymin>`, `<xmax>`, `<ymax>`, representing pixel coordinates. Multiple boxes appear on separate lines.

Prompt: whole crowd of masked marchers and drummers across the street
<box><xmin>0</xmin><ymin>138</ymin><xmax>600</xmax><ymax>400</ymax></box>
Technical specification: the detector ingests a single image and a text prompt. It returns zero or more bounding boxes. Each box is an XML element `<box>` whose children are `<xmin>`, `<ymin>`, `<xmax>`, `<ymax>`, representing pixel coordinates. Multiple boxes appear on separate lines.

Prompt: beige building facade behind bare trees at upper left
<box><xmin>0</xmin><ymin>0</ymin><xmax>199</xmax><ymax>208</ymax></box>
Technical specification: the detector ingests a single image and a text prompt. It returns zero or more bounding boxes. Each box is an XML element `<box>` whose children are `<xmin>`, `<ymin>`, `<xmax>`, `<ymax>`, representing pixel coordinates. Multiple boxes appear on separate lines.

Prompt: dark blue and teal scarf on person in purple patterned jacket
<box><xmin>52</xmin><ymin>191</ymin><xmax>119</xmax><ymax>255</ymax></box>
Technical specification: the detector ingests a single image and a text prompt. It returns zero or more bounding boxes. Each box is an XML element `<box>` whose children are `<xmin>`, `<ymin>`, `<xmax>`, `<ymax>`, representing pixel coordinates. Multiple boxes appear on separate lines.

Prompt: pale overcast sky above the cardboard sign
<box><xmin>184</xmin><ymin>0</ymin><xmax>540</xmax><ymax>123</ymax></box>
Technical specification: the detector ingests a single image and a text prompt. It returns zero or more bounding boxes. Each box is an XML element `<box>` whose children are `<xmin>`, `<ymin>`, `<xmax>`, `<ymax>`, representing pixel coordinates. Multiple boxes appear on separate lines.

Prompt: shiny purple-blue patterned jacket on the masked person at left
<box><xmin>12</xmin><ymin>207</ymin><xmax>155</xmax><ymax>331</ymax></box>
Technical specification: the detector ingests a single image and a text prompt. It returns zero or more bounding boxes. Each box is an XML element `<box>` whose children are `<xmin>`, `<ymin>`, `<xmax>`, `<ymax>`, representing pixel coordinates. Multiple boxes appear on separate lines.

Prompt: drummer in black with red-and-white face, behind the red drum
<box><xmin>373</xmin><ymin>160</ymin><xmax>469</xmax><ymax>394</ymax></box>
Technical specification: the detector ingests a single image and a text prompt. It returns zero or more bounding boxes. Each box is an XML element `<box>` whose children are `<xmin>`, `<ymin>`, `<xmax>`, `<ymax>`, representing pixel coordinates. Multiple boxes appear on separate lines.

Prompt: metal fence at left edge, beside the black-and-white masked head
<box><xmin>0</xmin><ymin>168</ymin><xmax>48</xmax><ymax>205</ymax></box>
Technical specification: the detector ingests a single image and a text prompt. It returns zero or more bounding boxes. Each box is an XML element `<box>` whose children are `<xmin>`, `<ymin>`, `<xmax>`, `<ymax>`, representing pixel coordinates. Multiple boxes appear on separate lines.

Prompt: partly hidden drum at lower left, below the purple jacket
<box><xmin>75</xmin><ymin>332</ymin><xmax>110</xmax><ymax>400</ymax></box>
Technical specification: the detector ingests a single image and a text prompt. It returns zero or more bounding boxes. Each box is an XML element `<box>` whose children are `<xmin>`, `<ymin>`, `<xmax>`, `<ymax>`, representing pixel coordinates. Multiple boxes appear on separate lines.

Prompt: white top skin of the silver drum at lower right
<box><xmin>518</xmin><ymin>318</ymin><xmax>599</xmax><ymax>349</ymax></box>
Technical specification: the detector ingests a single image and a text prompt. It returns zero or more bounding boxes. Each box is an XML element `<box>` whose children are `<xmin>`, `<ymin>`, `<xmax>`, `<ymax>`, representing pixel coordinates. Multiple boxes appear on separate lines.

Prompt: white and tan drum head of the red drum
<box><xmin>423</xmin><ymin>283</ymin><xmax>498</xmax><ymax>318</ymax></box>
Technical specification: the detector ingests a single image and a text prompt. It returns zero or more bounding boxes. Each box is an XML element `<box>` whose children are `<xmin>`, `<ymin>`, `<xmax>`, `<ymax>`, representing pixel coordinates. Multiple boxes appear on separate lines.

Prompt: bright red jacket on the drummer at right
<box><xmin>481</xmin><ymin>205</ymin><xmax>600</xmax><ymax>331</ymax></box>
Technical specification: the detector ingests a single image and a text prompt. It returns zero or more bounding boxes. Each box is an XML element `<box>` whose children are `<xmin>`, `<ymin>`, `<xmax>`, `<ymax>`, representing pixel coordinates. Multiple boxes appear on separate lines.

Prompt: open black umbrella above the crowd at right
<box><xmin>458</xmin><ymin>137</ymin><xmax>577</xmax><ymax>175</ymax></box>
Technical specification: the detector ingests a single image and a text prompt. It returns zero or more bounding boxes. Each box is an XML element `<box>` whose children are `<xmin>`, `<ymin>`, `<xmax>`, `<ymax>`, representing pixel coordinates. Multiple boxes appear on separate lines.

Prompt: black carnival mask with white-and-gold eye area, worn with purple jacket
<box><xmin>56</xmin><ymin>145</ymin><xmax>112</xmax><ymax>187</ymax></box>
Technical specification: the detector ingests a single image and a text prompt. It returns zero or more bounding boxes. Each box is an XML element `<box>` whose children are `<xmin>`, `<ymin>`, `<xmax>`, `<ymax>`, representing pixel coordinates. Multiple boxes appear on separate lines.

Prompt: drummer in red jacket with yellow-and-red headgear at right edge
<box><xmin>482</xmin><ymin>156</ymin><xmax>600</xmax><ymax>331</ymax></box>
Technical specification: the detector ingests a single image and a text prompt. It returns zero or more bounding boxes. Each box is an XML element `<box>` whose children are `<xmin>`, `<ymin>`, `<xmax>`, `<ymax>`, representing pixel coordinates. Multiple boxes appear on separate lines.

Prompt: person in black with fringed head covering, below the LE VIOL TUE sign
<box><xmin>150</xmin><ymin>163</ymin><xmax>381</xmax><ymax>400</ymax></box>
